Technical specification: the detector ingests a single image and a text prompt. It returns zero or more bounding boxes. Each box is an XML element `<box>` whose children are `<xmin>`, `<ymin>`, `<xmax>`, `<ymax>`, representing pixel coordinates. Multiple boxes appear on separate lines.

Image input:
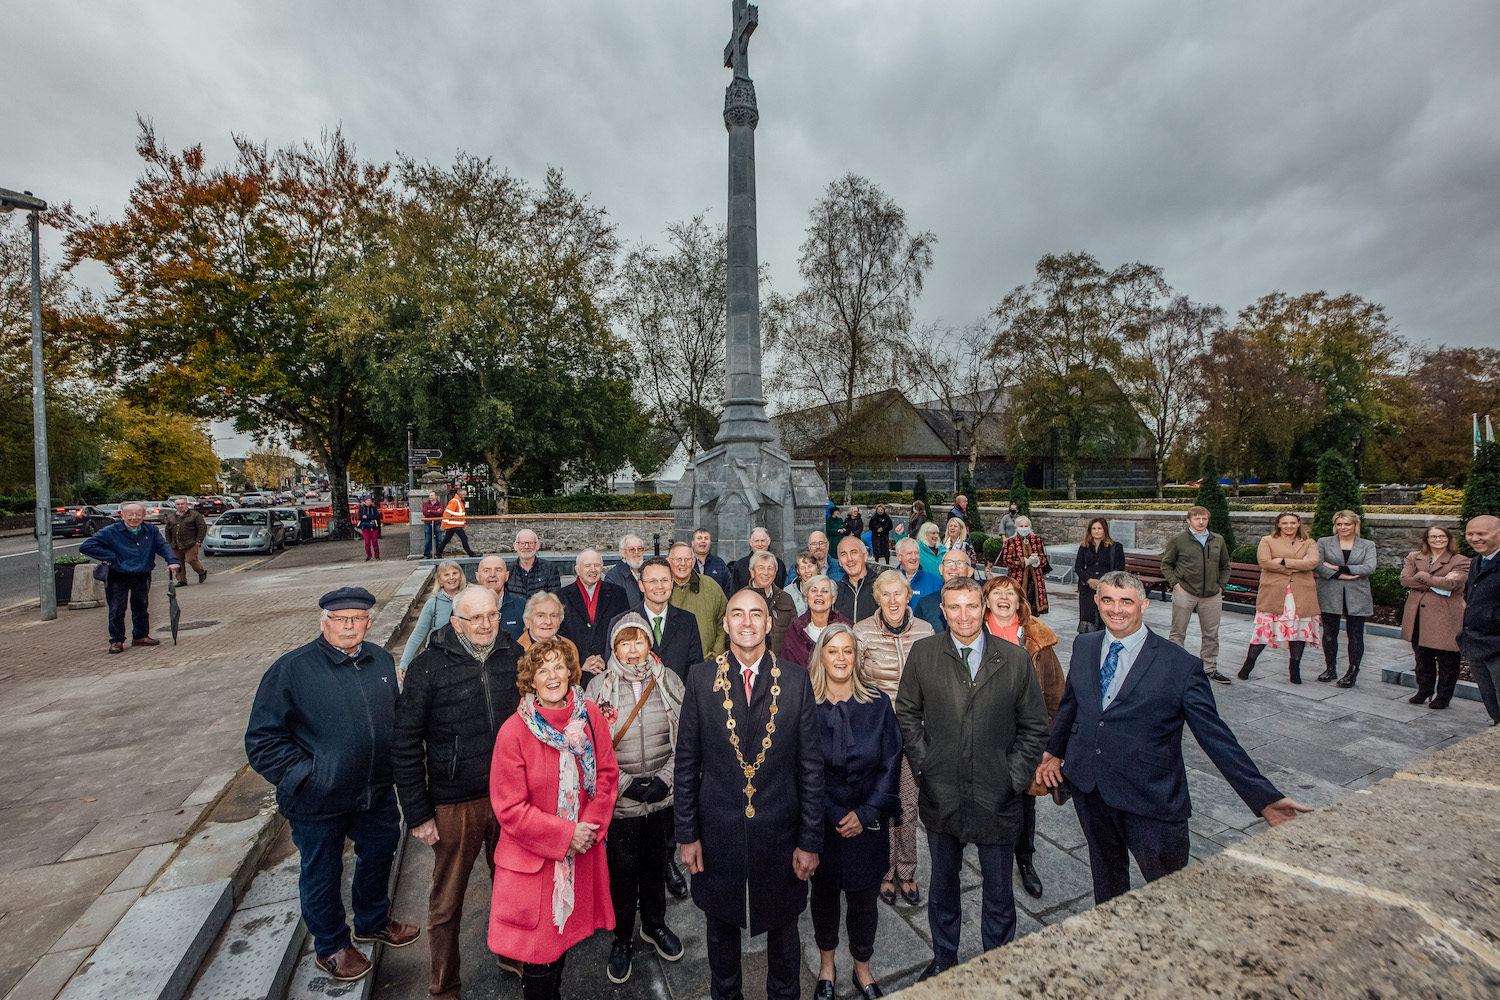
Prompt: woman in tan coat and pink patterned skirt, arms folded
<box><xmin>1239</xmin><ymin>511</ymin><xmax>1323</xmax><ymax>684</ymax></box>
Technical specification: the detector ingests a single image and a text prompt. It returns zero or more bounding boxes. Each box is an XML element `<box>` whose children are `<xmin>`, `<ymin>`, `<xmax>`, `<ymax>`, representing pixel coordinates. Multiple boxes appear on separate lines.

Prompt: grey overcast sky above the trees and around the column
<box><xmin>0</xmin><ymin>0</ymin><xmax>1500</xmax><ymax>452</ymax></box>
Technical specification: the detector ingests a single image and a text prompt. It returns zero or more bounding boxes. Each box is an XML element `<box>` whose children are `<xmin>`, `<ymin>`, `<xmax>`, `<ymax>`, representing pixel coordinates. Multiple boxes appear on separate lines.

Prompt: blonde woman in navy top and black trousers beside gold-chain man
<box><xmin>809</xmin><ymin>624</ymin><xmax>902</xmax><ymax>1000</ymax></box>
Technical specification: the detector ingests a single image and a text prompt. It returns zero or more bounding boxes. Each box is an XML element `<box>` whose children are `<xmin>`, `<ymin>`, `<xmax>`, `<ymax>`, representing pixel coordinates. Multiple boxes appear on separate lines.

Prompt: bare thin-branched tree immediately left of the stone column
<box><xmin>618</xmin><ymin>216</ymin><xmax>728</xmax><ymax>465</ymax></box>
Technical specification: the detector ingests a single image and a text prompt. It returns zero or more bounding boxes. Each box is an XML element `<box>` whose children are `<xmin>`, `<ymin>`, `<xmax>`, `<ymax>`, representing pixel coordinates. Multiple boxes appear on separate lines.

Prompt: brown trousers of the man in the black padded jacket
<box><xmin>428</xmin><ymin>798</ymin><xmax>500</xmax><ymax>997</ymax></box>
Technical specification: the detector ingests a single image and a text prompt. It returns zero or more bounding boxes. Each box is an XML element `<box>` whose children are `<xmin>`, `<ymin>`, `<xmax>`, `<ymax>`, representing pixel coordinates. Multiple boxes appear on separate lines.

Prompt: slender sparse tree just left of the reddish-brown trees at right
<box><xmin>1121</xmin><ymin>295</ymin><xmax>1224</xmax><ymax>499</ymax></box>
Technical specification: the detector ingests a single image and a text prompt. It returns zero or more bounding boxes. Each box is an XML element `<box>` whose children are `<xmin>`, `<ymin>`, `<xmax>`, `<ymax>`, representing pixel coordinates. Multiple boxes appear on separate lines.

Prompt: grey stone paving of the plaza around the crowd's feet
<box><xmin>375</xmin><ymin>588</ymin><xmax>1488</xmax><ymax>1000</ymax></box>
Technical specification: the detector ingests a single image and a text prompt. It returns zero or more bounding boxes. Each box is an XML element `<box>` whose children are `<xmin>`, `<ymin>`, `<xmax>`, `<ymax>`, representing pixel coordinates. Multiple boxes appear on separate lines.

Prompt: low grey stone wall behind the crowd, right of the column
<box><xmin>882</xmin><ymin>504</ymin><xmax>1458</xmax><ymax>568</ymax></box>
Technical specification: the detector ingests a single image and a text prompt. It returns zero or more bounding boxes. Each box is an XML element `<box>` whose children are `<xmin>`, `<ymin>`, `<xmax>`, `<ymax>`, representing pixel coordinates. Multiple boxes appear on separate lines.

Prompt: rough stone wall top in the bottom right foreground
<box><xmin>908</xmin><ymin>729</ymin><xmax>1500</xmax><ymax>1000</ymax></box>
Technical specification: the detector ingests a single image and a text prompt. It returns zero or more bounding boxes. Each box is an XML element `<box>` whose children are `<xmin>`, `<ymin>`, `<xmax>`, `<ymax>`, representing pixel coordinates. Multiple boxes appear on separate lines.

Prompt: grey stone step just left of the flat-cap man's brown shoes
<box><xmin>188</xmin><ymin>855</ymin><xmax>308</xmax><ymax>1000</ymax></box>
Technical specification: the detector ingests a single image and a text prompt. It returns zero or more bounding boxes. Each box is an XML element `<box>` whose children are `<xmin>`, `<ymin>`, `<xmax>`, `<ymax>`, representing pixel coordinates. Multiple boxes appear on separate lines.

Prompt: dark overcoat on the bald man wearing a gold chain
<box><xmin>672</xmin><ymin>652</ymin><xmax>828</xmax><ymax>934</ymax></box>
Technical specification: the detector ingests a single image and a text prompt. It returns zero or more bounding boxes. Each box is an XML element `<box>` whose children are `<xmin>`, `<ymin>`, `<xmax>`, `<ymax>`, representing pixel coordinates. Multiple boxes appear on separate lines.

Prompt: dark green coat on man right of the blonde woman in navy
<box><xmin>896</xmin><ymin>633</ymin><xmax>1047</xmax><ymax>844</ymax></box>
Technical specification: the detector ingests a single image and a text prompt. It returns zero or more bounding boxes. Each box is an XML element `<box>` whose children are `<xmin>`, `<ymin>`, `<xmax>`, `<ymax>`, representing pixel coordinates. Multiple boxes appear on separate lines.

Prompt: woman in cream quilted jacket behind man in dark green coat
<box><xmin>854</xmin><ymin>570</ymin><xmax>933</xmax><ymax>906</ymax></box>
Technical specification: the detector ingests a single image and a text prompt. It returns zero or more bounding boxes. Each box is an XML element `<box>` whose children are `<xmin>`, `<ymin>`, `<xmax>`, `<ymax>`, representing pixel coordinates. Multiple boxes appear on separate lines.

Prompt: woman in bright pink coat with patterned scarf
<box><xmin>489</xmin><ymin>639</ymin><xmax>620</xmax><ymax>1000</ymax></box>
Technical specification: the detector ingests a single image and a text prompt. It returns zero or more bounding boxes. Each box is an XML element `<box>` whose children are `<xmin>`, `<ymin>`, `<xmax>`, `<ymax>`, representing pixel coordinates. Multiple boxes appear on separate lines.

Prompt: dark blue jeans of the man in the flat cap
<box><xmin>291</xmin><ymin>792</ymin><xmax>401</xmax><ymax>958</ymax></box>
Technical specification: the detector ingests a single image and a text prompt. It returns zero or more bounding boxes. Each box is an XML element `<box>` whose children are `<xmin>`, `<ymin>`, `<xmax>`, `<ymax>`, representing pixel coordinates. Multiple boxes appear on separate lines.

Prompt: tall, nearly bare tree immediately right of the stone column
<box><xmin>765</xmin><ymin>174</ymin><xmax>938</xmax><ymax>502</ymax></box>
